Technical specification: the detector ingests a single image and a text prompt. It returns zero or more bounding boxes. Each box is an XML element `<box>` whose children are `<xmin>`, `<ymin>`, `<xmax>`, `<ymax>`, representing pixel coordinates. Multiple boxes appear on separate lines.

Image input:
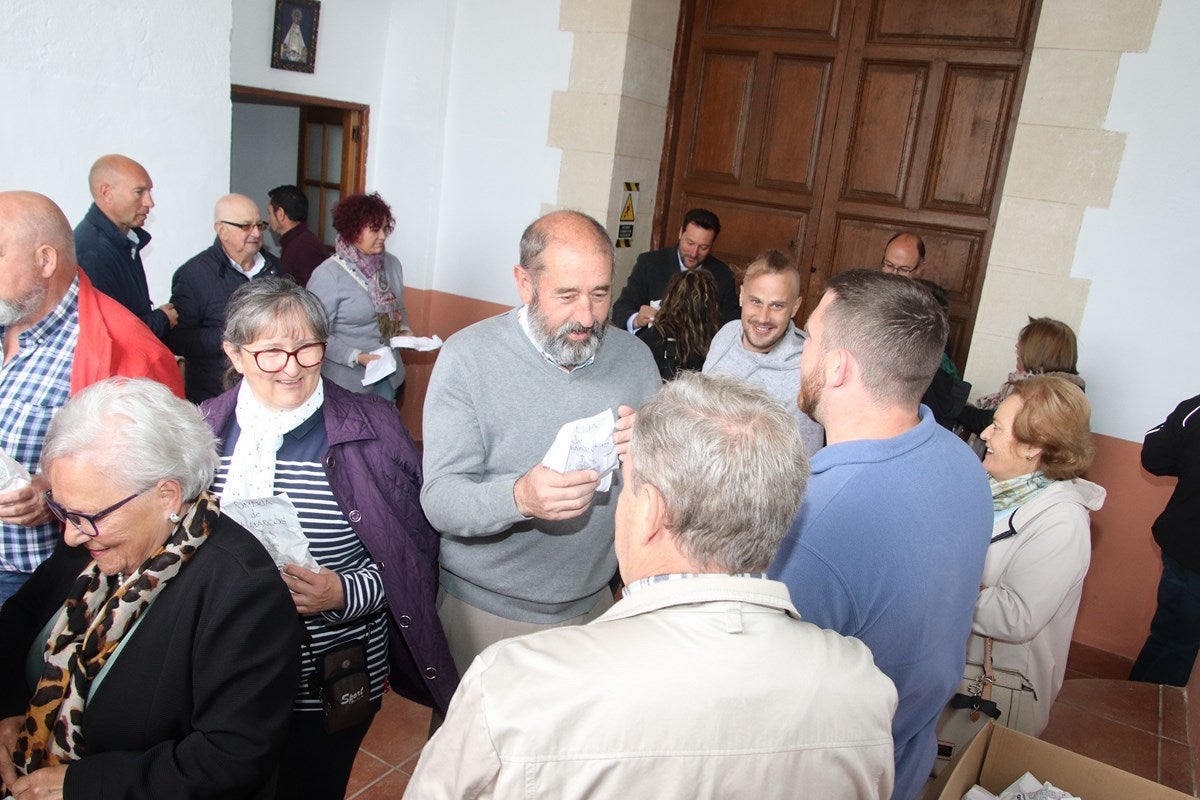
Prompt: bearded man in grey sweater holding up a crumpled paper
<box><xmin>421</xmin><ymin>211</ymin><xmax>660</xmax><ymax>673</ymax></box>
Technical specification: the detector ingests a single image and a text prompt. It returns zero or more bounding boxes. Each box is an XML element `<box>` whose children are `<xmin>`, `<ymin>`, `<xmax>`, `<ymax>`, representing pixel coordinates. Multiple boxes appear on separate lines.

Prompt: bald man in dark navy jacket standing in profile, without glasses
<box><xmin>74</xmin><ymin>155</ymin><xmax>179</xmax><ymax>339</ymax></box>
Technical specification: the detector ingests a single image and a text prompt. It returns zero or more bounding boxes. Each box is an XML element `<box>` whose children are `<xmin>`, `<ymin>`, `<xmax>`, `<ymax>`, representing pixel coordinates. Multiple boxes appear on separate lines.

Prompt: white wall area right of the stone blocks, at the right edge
<box><xmin>1072</xmin><ymin>0</ymin><xmax>1200</xmax><ymax>441</ymax></box>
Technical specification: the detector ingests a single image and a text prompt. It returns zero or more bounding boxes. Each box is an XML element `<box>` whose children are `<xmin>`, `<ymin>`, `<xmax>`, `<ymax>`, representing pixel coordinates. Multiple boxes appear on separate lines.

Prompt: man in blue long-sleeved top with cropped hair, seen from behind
<box><xmin>769</xmin><ymin>270</ymin><xmax>992</xmax><ymax>800</ymax></box>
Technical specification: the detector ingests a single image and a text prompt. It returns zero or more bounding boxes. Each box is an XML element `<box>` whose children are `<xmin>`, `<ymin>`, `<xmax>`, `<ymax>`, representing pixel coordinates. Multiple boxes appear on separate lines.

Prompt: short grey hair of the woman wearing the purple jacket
<box><xmin>222</xmin><ymin>275</ymin><xmax>329</xmax><ymax>347</ymax></box>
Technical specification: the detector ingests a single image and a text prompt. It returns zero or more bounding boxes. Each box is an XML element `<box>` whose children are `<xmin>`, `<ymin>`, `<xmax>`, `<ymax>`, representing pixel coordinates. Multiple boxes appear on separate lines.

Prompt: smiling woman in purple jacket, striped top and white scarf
<box><xmin>203</xmin><ymin>277</ymin><xmax>458</xmax><ymax>799</ymax></box>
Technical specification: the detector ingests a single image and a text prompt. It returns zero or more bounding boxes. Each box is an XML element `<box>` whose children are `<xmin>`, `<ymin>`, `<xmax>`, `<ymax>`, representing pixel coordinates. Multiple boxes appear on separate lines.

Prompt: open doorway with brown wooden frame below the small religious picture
<box><xmin>229</xmin><ymin>85</ymin><xmax>370</xmax><ymax>251</ymax></box>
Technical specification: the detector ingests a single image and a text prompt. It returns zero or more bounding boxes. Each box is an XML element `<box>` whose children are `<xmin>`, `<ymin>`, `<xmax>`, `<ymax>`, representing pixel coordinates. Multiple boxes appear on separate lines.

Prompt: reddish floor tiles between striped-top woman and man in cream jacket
<box><xmin>346</xmin><ymin>692</ymin><xmax>430</xmax><ymax>800</ymax></box>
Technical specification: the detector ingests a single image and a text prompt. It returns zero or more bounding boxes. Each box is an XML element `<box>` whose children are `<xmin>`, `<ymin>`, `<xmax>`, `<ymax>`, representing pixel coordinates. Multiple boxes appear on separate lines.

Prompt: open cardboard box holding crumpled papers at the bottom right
<box><xmin>925</xmin><ymin>723</ymin><xmax>1189</xmax><ymax>800</ymax></box>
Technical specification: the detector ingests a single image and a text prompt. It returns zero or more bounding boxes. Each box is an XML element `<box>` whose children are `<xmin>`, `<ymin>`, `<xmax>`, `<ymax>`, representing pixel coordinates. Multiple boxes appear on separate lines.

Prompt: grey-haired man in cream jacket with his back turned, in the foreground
<box><xmin>406</xmin><ymin>373</ymin><xmax>896</xmax><ymax>800</ymax></box>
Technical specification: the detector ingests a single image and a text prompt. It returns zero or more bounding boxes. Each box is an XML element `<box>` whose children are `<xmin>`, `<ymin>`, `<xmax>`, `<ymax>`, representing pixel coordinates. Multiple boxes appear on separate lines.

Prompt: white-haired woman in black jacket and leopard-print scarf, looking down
<box><xmin>0</xmin><ymin>378</ymin><xmax>300</xmax><ymax>799</ymax></box>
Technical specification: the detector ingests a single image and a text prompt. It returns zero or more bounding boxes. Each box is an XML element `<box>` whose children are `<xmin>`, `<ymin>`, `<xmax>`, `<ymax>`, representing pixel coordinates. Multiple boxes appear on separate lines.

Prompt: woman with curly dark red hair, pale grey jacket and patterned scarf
<box><xmin>307</xmin><ymin>192</ymin><xmax>412</xmax><ymax>401</ymax></box>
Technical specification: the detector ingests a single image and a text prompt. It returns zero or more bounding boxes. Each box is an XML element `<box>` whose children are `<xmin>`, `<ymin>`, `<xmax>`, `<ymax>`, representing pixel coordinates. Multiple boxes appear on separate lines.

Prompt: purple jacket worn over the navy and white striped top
<box><xmin>202</xmin><ymin>379</ymin><xmax>458</xmax><ymax>714</ymax></box>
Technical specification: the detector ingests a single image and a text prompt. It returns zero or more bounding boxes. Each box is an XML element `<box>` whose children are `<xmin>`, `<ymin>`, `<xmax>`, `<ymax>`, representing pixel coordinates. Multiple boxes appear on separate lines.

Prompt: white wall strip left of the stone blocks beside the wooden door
<box><xmin>431</xmin><ymin>0</ymin><xmax>572</xmax><ymax>303</ymax></box>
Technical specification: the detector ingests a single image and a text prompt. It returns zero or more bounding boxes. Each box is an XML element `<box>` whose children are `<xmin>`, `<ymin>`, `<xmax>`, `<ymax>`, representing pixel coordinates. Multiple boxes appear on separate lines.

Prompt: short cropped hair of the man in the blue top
<box><xmin>821</xmin><ymin>270</ymin><xmax>949</xmax><ymax>409</ymax></box>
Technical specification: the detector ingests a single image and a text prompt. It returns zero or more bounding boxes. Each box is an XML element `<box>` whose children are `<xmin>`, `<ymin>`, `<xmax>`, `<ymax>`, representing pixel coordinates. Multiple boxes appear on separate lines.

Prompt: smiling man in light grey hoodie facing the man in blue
<box><xmin>703</xmin><ymin>249</ymin><xmax>824</xmax><ymax>456</ymax></box>
